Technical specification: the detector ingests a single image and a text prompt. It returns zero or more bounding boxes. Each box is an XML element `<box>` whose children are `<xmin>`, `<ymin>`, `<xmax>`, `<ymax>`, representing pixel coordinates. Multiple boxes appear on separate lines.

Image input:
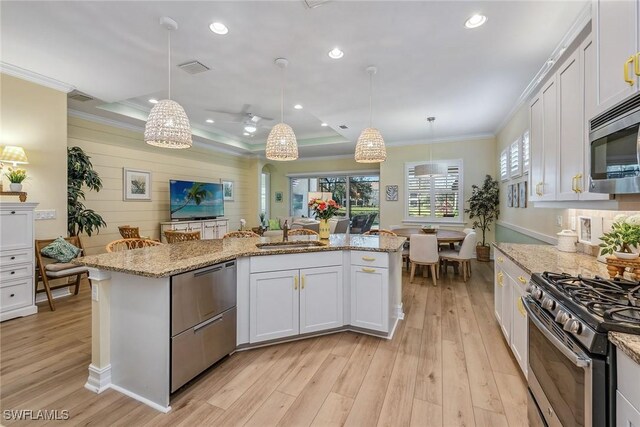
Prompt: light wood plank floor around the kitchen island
<box><xmin>0</xmin><ymin>262</ymin><xmax>527</xmax><ymax>427</ymax></box>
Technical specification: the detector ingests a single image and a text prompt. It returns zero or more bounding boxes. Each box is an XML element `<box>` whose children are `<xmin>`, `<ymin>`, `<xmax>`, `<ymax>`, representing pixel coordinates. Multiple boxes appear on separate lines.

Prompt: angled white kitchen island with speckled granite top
<box><xmin>77</xmin><ymin>235</ymin><xmax>405</xmax><ymax>412</ymax></box>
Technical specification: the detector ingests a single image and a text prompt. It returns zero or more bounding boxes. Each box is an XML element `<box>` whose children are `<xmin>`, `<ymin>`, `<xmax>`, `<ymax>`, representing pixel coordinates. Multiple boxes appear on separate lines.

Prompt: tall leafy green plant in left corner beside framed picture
<box><xmin>67</xmin><ymin>147</ymin><xmax>107</xmax><ymax>236</ymax></box>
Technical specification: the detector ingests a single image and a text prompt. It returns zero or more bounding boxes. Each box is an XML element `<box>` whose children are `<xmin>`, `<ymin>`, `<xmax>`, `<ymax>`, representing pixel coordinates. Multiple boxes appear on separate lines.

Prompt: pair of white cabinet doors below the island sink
<box><xmin>249</xmin><ymin>266</ymin><xmax>344</xmax><ymax>343</ymax></box>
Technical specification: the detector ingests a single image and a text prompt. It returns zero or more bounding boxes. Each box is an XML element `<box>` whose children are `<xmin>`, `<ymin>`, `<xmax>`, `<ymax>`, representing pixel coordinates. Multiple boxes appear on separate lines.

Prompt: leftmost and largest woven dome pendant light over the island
<box><xmin>144</xmin><ymin>16</ymin><xmax>193</xmax><ymax>148</ymax></box>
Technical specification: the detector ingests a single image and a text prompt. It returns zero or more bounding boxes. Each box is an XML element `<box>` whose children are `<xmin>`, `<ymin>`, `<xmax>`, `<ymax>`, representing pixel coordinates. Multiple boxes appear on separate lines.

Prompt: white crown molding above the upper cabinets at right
<box><xmin>494</xmin><ymin>2</ymin><xmax>592</xmax><ymax>135</ymax></box>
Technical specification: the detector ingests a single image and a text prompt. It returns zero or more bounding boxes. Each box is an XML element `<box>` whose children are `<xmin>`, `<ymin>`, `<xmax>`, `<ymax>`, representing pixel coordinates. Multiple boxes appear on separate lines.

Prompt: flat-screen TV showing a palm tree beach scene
<box><xmin>169</xmin><ymin>179</ymin><xmax>224</xmax><ymax>221</ymax></box>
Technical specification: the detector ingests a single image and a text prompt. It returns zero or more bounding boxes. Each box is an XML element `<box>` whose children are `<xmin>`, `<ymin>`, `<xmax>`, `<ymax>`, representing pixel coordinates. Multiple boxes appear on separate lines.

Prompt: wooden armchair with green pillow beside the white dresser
<box><xmin>35</xmin><ymin>236</ymin><xmax>91</xmax><ymax>311</ymax></box>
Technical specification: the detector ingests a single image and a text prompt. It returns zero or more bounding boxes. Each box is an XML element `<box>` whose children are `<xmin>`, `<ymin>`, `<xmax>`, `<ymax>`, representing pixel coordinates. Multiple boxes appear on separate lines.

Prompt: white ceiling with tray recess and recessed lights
<box><xmin>0</xmin><ymin>0</ymin><xmax>586</xmax><ymax>157</ymax></box>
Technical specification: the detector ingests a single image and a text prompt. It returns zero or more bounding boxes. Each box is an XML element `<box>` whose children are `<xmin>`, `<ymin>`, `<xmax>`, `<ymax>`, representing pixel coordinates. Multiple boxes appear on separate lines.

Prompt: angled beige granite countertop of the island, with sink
<box><xmin>74</xmin><ymin>234</ymin><xmax>406</xmax><ymax>277</ymax></box>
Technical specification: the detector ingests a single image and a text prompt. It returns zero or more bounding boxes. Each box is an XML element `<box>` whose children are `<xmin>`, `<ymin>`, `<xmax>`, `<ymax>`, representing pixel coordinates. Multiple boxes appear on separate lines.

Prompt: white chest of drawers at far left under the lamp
<box><xmin>0</xmin><ymin>201</ymin><xmax>38</xmax><ymax>321</ymax></box>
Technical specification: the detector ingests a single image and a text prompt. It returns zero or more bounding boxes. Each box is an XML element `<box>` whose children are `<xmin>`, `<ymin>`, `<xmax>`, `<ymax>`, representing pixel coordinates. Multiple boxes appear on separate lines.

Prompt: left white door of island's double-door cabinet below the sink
<box><xmin>249</xmin><ymin>270</ymin><xmax>300</xmax><ymax>343</ymax></box>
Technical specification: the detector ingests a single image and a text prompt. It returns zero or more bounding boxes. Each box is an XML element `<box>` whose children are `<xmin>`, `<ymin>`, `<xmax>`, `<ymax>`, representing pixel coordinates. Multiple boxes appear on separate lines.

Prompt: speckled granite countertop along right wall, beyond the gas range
<box><xmin>493</xmin><ymin>243</ymin><xmax>609</xmax><ymax>278</ymax></box>
